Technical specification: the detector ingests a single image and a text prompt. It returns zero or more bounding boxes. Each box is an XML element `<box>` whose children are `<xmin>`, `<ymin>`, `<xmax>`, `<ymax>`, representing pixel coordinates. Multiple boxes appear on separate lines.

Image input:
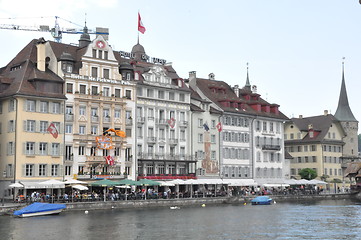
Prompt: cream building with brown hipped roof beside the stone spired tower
<box><xmin>285</xmin><ymin>111</ymin><xmax>346</xmax><ymax>180</ymax></box>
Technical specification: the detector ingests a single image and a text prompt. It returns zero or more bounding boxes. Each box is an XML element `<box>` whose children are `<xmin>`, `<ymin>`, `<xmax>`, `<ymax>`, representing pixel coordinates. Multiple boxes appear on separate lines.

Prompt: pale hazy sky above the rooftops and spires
<box><xmin>0</xmin><ymin>0</ymin><xmax>361</xmax><ymax>132</ymax></box>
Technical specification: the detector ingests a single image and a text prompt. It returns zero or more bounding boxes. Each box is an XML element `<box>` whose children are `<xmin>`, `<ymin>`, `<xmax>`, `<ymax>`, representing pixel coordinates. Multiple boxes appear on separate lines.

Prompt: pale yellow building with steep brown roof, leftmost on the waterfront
<box><xmin>0</xmin><ymin>39</ymin><xmax>66</xmax><ymax>197</ymax></box>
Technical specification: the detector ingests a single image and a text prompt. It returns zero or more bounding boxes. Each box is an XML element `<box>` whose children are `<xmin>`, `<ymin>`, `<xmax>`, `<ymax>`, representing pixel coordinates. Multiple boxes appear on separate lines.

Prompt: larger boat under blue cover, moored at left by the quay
<box><xmin>14</xmin><ymin>202</ymin><xmax>66</xmax><ymax>217</ymax></box>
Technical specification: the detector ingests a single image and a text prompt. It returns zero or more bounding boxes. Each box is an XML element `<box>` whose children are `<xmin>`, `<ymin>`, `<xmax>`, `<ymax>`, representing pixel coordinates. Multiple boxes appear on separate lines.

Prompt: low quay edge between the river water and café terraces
<box><xmin>0</xmin><ymin>193</ymin><xmax>356</xmax><ymax>215</ymax></box>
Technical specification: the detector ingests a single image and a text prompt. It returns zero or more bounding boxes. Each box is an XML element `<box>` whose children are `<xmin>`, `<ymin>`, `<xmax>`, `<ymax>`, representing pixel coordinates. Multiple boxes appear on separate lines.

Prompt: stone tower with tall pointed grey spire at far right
<box><xmin>335</xmin><ymin>63</ymin><xmax>358</xmax><ymax>163</ymax></box>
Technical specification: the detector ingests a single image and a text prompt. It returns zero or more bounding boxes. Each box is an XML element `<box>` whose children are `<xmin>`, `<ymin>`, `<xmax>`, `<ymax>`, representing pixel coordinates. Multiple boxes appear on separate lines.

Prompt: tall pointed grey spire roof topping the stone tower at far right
<box><xmin>335</xmin><ymin>58</ymin><xmax>357</xmax><ymax>122</ymax></box>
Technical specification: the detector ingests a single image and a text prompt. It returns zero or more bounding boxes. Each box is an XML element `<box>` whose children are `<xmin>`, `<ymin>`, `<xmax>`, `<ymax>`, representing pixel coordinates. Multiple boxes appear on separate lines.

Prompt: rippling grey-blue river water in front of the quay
<box><xmin>0</xmin><ymin>200</ymin><xmax>361</xmax><ymax>240</ymax></box>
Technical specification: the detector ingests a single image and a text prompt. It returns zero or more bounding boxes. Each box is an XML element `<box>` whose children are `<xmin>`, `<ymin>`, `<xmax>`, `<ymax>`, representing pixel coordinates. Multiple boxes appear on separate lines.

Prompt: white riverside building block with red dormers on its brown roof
<box><xmin>189</xmin><ymin>72</ymin><xmax>288</xmax><ymax>183</ymax></box>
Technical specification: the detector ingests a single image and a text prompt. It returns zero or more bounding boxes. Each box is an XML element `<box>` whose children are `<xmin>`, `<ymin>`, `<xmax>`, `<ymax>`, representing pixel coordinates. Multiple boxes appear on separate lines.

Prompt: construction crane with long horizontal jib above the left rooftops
<box><xmin>0</xmin><ymin>16</ymin><xmax>109</xmax><ymax>42</ymax></box>
